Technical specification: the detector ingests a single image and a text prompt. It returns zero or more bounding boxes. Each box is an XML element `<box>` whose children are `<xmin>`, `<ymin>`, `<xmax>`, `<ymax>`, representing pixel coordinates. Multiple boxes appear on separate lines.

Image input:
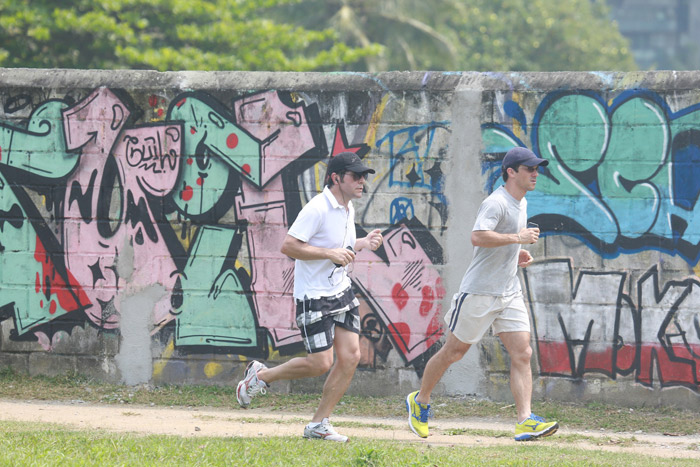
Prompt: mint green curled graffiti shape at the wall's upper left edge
<box><xmin>0</xmin><ymin>101</ymin><xmax>79</xmax><ymax>178</ymax></box>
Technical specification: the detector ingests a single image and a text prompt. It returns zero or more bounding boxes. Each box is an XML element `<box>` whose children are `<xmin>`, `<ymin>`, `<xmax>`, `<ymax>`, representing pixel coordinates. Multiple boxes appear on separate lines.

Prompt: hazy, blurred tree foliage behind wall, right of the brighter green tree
<box><xmin>276</xmin><ymin>0</ymin><xmax>636</xmax><ymax>71</ymax></box>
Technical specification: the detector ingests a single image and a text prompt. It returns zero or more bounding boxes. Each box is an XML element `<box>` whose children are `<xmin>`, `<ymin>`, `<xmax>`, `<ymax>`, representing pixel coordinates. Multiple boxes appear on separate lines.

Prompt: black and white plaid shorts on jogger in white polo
<box><xmin>296</xmin><ymin>287</ymin><xmax>360</xmax><ymax>353</ymax></box>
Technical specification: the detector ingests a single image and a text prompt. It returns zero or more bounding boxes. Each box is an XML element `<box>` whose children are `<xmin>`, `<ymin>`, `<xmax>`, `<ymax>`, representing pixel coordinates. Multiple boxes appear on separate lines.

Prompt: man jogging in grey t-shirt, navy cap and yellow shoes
<box><xmin>406</xmin><ymin>147</ymin><xmax>559</xmax><ymax>441</ymax></box>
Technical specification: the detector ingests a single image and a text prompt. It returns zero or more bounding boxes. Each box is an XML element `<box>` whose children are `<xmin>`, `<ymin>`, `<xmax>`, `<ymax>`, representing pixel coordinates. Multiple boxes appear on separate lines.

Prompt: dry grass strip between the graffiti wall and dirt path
<box><xmin>0</xmin><ymin>369</ymin><xmax>700</xmax><ymax>436</ymax></box>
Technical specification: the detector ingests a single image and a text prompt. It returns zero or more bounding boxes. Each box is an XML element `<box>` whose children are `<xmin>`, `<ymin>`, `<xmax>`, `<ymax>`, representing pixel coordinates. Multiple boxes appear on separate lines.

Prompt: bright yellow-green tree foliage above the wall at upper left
<box><xmin>0</xmin><ymin>0</ymin><xmax>379</xmax><ymax>71</ymax></box>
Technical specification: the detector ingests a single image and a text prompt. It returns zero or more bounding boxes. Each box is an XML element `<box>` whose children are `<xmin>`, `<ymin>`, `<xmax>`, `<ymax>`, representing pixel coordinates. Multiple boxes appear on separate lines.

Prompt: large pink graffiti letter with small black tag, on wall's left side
<box><xmin>63</xmin><ymin>88</ymin><xmax>182</xmax><ymax>328</ymax></box>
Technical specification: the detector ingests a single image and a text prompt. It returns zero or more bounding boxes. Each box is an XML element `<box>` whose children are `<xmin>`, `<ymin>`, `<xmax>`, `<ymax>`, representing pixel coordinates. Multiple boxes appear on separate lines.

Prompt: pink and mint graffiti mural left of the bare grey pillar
<box><xmin>0</xmin><ymin>71</ymin><xmax>451</xmax><ymax>394</ymax></box>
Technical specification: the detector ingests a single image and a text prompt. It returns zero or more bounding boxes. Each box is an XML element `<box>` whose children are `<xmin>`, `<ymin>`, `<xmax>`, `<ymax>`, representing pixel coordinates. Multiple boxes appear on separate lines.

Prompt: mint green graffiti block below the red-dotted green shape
<box><xmin>175</xmin><ymin>226</ymin><xmax>259</xmax><ymax>348</ymax></box>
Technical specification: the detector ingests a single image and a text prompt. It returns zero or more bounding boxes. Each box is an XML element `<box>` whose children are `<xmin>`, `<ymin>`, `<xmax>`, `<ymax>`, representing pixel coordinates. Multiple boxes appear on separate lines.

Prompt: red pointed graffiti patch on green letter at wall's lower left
<box><xmin>34</xmin><ymin>237</ymin><xmax>91</xmax><ymax>313</ymax></box>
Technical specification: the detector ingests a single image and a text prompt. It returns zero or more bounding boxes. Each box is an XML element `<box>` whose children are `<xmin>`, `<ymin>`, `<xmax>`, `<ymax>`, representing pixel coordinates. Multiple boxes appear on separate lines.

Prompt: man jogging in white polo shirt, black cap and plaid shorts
<box><xmin>236</xmin><ymin>152</ymin><xmax>383</xmax><ymax>442</ymax></box>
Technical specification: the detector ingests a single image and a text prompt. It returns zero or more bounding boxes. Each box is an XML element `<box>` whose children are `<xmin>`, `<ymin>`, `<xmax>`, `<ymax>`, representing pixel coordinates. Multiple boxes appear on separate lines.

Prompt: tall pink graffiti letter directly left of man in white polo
<box><xmin>233</xmin><ymin>91</ymin><xmax>324</xmax><ymax>346</ymax></box>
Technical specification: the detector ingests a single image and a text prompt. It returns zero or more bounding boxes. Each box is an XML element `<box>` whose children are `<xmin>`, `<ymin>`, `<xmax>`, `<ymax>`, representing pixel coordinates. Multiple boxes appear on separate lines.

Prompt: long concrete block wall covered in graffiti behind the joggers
<box><xmin>0</xmin><ymin>69</ymin><xmax>700</xmax><ymax>407</ymax></box>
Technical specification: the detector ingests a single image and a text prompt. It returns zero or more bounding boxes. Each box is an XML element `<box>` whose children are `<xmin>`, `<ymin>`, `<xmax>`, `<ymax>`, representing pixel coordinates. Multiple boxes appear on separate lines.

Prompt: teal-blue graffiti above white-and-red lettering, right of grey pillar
<box><xmin>482</xmin><ymin>76</ymin><xmax>700</xmax><ymax>401</ymax></box>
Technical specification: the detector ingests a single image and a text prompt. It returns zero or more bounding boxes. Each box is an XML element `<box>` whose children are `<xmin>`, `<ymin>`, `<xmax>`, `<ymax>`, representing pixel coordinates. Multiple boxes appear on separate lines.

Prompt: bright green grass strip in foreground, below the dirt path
<box><xmin>0</xmin><ymin>422</ymin><xmax>697</xmax><ymax>467</ymax></box>
